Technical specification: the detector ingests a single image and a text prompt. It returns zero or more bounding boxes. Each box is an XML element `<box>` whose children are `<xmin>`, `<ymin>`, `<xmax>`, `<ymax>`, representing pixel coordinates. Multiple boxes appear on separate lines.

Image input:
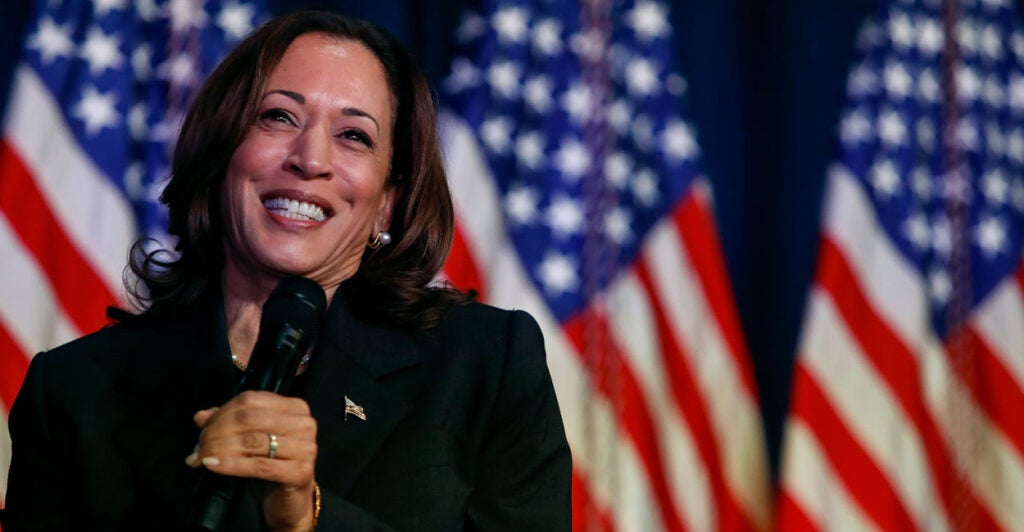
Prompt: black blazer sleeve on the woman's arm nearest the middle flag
<box><xmin>467</xmin><ymin>311</ymin><xmax>572</xmax><ymax>531</ymax></box>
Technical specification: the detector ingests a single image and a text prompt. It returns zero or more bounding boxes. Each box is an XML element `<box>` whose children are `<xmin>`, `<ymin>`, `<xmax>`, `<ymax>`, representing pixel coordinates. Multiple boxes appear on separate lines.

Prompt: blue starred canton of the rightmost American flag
<box><xmin>840</xmin><ymin>0</ymin><xmax>1024</xmax><ymax>336</ymax></box>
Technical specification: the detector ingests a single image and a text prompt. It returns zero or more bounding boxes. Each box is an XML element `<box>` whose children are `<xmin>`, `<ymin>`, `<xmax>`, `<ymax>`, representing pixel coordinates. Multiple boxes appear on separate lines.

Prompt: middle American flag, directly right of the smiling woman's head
<box><xmin>441</xmin><ymin>0</ymin><xmax>771</xmax><ymax>531</ymax></box>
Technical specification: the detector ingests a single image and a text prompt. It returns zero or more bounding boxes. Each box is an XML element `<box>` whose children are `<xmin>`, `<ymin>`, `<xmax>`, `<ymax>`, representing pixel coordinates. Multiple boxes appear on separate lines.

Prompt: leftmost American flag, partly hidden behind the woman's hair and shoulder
<box><xmin>0</xmin><ymin>0</ymin><xmax>265</xmax><ymax>502</ymax></box>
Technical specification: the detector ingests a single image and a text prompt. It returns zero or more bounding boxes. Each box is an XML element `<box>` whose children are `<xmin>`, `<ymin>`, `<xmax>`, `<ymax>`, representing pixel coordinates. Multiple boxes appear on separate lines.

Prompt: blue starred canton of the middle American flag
<box><xmin>442</xmin><ymin>0</ymin><xmax>699</xmax><ymax>320</ymax></box>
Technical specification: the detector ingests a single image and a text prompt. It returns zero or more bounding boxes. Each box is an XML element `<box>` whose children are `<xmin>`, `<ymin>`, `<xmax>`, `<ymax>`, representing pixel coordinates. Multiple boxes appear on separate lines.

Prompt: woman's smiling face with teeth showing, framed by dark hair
<box><xmin>221</xmin><ymin>34</ymin><xmax>393</xmax><ymax>291</ymax></box>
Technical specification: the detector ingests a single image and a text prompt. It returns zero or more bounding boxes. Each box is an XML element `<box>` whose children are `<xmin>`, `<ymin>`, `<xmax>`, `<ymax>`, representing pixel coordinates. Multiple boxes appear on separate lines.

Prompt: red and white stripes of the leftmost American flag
<box><xmin>0</xmin><ymin>68</ymin><xmax>136</xmax><ymax>503</ymax></box>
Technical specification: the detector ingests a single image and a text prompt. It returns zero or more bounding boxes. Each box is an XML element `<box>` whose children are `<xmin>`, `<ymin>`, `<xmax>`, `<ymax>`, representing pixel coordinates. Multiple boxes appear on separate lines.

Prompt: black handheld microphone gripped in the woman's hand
<box><xmin>189</xmin><ymin>276</ymin><xmax>327</xmax><ymax>531</ymax></box>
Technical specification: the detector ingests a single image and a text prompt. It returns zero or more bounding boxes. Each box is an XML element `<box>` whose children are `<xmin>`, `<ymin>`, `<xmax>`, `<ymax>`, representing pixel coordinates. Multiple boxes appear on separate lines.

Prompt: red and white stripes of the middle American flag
<box><xmin>441</xmin><ymin>116</ymin><xmax>771</xmax><ymax>531</ymax></box>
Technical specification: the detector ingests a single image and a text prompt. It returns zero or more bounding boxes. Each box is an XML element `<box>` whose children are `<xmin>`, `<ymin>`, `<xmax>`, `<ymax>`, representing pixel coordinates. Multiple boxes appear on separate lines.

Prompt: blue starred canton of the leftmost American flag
<box><xmin>22</xmin><ymin>0</ymin><xmax>266</xmax><ymax>236</ymax></box>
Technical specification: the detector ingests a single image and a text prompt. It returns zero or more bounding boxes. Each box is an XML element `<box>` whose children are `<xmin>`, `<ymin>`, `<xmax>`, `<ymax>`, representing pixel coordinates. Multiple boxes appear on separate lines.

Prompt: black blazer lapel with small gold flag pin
<box><xmin>305</xmin><ymin>292</ymin><xmax>426</xmax><ymax>494</ymax></box>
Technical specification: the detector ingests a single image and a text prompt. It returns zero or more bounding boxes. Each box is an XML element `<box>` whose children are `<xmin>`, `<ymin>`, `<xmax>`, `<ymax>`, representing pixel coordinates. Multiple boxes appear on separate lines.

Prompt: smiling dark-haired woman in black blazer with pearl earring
<box><xmin>3</xmin><ymin>12</ymin><xmax>571</xmax><ymax>532</ymax></box>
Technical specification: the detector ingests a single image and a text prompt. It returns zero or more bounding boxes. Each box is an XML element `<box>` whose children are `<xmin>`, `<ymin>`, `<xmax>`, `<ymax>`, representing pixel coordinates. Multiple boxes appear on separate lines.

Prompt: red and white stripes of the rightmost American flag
<box><xmin>778</xmin><ymin>167</ymin><xmax>1024</xmax><ymax>531</ymax></box>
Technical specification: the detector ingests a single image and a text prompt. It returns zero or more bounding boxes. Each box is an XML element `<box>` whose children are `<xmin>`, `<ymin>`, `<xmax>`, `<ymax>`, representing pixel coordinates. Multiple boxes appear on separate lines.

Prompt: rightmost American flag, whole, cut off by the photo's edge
<box><xmin>778</xmin><ymin>0</ymin><xmax>1024</xmax><ymax>531</ymax></box>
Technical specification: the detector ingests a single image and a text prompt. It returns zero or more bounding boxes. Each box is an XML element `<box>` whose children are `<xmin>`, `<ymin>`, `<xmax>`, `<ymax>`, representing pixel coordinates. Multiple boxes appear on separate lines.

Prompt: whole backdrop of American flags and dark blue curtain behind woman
<box><xmin>0</xmin><ymin>0</ymin><xmax>1024</xmax><ymax>531</ymax></box>
